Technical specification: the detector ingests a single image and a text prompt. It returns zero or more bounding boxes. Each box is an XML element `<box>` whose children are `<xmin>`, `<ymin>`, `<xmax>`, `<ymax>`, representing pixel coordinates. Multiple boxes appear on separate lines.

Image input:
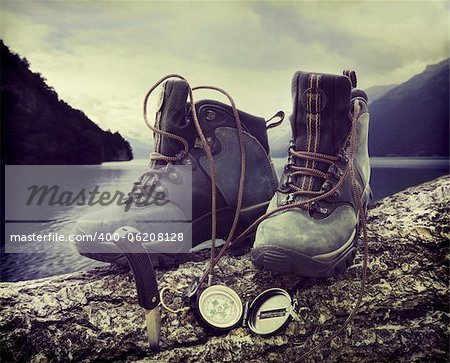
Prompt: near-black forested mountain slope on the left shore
<box><xmin>0</xmin><ymin>41</ymin><xmax>133</xmax><ymax>164</ymax></box>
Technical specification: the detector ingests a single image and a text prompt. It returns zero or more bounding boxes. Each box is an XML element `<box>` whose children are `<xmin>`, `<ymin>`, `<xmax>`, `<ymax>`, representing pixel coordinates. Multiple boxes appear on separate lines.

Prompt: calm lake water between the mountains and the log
<box><xmin>0</xmin><ymin>158</ymin><xmax>449</xmax><ymax>281</ymax></box>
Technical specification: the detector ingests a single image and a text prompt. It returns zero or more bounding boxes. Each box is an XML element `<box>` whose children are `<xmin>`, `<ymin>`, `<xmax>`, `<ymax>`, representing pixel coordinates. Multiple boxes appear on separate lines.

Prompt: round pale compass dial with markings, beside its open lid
<box><xmin>199</xmin><ymin>286</ymin><xmax>242</xmax><ymax>328</ymax></box>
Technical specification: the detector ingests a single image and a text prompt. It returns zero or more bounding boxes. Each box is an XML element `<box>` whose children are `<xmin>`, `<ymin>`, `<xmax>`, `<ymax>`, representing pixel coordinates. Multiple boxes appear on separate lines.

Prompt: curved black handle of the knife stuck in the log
<box><xmin>114</xmin><ymin>227</ymin><xmax>160</xmax><ymax>310</ymax></box>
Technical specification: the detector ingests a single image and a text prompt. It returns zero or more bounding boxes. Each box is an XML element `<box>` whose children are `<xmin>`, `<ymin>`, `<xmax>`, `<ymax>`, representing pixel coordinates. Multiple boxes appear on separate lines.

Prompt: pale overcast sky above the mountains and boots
<box><xmin>0</xmin><ymin>0</ymin><xmax>449</xmax><ymax>148</ymax></box>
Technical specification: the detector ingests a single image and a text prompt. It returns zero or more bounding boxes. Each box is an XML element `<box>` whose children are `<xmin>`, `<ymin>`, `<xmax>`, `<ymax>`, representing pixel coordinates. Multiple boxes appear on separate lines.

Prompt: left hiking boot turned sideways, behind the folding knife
<box><xmin>76</xmin><ymin>80</ymin><xmax>278</xmax><ymax>267</ymax></box>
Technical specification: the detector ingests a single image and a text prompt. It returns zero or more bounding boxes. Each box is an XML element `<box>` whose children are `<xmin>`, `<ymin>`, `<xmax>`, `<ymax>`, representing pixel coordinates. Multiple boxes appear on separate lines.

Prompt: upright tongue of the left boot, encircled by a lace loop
<box><xmin>156</xmin><ymin>79</ymin><xmax>192</xmax><ymax>159</ymax></box>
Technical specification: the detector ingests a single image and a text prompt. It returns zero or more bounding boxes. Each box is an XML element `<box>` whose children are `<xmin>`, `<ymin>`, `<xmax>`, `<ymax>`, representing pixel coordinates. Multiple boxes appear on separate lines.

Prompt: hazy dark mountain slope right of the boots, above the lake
<box><xmin>369</xmin><ymin>59</ymin><xmax>449</xmax><ymax>156</ymax></box>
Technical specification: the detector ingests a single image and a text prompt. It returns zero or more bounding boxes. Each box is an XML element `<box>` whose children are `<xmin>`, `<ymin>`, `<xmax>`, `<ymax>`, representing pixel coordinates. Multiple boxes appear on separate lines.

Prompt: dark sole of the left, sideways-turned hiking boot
<box><xmin>74</xmin><ymin>201</ymin><xmax>269</xmax><ymax>269</ymax></box>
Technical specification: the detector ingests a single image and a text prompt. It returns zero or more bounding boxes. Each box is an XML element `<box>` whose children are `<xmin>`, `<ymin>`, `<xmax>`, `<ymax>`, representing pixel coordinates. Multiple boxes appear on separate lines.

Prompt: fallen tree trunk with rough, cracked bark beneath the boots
<box><xmin>0</xmin><ymin>176</ymin><xmax>450</xmax><ymax>362</ymax></box>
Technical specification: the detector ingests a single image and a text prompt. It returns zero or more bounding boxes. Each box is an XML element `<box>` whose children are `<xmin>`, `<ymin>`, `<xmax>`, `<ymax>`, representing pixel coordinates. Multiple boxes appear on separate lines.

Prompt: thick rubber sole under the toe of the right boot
<box><xmin>250</xmin><ymin>231</ymin><xmax>358</xmax><ymax>277</ymax></box>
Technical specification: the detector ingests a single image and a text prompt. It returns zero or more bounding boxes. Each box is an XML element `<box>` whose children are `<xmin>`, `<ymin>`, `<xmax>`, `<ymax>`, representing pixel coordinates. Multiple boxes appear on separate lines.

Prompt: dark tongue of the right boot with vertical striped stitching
<box><xmin>290</xmin><ymin>72</ymin><xmax>352</xmax><ymax>190</ymax></box>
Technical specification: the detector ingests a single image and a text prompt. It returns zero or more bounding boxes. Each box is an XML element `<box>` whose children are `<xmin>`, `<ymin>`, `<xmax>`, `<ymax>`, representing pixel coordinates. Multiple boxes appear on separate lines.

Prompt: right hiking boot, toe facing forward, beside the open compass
<box><xmin>251</xmin><ymin>72</ymin><xmax>371</xmax><ymax>277</ymax></box>
